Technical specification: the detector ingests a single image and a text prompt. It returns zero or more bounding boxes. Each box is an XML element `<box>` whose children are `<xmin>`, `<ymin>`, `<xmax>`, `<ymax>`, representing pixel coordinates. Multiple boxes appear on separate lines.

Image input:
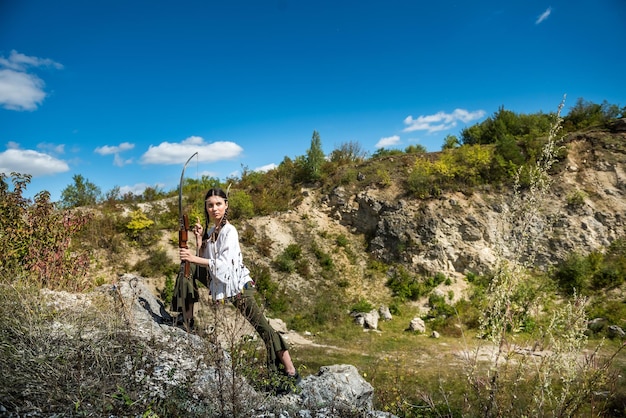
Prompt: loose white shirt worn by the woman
<box><xmin>200</xmin><ymin>223</ymin><xmax>252</xmax><ymax>300</ymax></box>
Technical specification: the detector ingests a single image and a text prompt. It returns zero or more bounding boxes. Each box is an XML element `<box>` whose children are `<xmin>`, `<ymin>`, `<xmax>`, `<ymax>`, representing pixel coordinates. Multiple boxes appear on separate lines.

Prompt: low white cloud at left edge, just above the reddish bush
<box><xmin>0</xmin><ymin>148</ymin><xmax>70</xmax><ymax>177</ymax></box>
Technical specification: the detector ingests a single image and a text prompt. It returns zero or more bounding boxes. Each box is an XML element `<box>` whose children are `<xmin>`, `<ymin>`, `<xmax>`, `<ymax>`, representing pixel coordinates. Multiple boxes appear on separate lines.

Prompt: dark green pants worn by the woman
<box><xmin>231</xmin><ymin>286</ymin><xmax>289</xmax><ymax>371</ymax></box>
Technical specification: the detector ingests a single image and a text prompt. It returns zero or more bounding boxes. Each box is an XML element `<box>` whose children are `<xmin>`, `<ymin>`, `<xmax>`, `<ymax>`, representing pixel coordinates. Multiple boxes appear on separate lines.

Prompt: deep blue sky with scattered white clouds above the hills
<box><xmin>0</xmin><ymin>0</ymin><xmax>626</xmax><ymax>200</ymax></box>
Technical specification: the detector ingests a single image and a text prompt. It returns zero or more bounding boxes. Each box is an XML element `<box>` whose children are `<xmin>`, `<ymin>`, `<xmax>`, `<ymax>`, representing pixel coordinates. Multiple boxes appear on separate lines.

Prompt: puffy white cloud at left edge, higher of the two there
<box><xmin>0</xmin><ymin>51</ymin><xmax>63</xmax><ymax>111</ymax></box>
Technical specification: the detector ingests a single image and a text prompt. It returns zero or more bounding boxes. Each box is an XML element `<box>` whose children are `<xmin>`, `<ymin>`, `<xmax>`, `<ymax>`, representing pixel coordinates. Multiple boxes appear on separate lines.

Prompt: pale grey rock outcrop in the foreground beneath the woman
<box><xmin>45</xmin><ymin>274</ymin><xmax>392</xmax><ymax>418</ymax></box>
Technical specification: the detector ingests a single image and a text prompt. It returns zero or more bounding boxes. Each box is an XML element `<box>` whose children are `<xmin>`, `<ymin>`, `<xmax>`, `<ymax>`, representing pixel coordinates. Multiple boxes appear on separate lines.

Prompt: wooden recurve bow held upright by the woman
<box><xmin>172</xmin><ymin>152</ymin><xmax>198</xmax><ymax>320</ymax></box>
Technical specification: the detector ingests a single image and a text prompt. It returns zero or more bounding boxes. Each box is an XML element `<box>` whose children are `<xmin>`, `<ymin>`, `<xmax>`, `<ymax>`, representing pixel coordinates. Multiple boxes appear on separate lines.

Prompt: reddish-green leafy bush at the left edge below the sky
<box><xmin>0</xmin><ymin>173</ymin><xmax>91</xmax><ymax>291</ymax></box>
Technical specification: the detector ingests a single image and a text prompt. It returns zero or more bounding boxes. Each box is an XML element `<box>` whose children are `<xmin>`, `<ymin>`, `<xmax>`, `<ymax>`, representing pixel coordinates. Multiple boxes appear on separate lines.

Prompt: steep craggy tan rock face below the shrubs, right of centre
<box><xmin>321</xmin><ymin>128</ymin><xmax>626</xmax><ymax>274</ymax></box>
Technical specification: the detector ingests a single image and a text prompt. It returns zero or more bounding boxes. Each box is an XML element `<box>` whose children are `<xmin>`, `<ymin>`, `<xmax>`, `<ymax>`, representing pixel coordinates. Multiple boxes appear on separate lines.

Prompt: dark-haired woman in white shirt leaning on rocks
<box><xmin>180</xmin><ymin>188</ymin><xmax>300</xmax><ymax>383</ymax></box>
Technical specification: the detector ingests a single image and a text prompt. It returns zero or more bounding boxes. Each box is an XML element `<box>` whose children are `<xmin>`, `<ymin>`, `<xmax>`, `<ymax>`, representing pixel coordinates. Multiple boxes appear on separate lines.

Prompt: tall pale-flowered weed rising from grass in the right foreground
<box><xmin>456</xmin><ymin>97</ymin><xmax>611</xmax><ymax>417</ymax></box>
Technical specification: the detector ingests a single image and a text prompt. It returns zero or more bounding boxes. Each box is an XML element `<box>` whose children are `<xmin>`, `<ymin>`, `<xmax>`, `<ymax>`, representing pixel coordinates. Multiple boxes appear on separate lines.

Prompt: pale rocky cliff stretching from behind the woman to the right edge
<box><xmin>240</xmin><ymin>129</ymin><xmax>626</xmax><ymax>304</ymax></box>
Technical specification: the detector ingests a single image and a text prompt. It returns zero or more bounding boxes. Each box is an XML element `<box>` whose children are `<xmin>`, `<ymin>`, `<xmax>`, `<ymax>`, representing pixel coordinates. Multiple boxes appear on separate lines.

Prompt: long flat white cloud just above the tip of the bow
<box><xmin>141</xmin><ymin>136</ymin><xmax>243</xmax><ymax>164</ymax></box>
